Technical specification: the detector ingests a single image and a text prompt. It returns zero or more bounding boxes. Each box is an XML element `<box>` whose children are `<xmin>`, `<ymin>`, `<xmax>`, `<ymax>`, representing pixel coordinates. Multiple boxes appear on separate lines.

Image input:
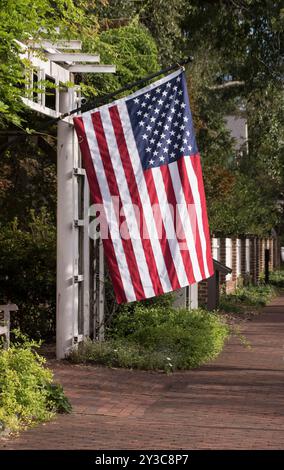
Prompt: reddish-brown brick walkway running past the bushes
<box><xmin>0</xmin><ymin>297</ymin><xmax>284</xmax><ymax>450</ymax></box>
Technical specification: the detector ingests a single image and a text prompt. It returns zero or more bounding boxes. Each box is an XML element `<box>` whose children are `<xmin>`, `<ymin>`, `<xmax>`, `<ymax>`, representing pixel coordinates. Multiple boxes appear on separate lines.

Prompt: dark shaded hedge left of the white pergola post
<box><xmin>0</xmin><ymin>210</ymin><xmax>56</xmax><ymax>340</ymax></box>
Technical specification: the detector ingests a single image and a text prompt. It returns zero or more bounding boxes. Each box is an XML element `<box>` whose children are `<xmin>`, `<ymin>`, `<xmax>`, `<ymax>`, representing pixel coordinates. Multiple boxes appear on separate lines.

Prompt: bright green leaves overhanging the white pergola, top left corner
<box><xmin>0</xmin><ymin>0</ymin><xmax>97</xmax><ymax>127</ymax></box>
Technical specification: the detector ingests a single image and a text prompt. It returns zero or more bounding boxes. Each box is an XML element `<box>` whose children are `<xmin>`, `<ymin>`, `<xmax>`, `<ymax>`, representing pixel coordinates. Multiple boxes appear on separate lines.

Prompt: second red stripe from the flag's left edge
<box><xmin>92</xmin><ymin>112</ymin><xmax>148</xmax><ymax>300</ymax></box>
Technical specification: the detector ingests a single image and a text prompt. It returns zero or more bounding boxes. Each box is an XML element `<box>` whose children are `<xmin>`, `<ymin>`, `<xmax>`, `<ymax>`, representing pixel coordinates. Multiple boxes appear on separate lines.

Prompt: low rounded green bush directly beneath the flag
<box><xmin>70</xmin><ymin>304</ymin><xmax>229</xmax><ymax>372</ymax></box>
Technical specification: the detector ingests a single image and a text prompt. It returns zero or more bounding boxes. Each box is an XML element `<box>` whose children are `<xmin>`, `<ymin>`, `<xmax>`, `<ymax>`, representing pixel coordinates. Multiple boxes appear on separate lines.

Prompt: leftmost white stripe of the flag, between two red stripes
<box><xmin>83</xmin><ymin>113</ymin><xmax>137</xmax><ymax>302</ymax></box>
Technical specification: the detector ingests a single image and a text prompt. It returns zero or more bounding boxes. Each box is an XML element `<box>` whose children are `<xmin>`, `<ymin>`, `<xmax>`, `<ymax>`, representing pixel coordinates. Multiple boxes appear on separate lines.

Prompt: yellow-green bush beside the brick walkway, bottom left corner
<box><xmin>0</xmin><ymin>335</ymin><xmax>70</xmax><ymax>431</ymax></box>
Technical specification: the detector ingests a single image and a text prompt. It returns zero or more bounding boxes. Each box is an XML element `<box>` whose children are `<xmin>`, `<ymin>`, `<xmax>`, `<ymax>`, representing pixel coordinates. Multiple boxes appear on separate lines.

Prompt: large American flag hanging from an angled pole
<box><xmin>74</xmin><ymin>70</ymin><xmax>213</xmax><ymax>303</ymax></box>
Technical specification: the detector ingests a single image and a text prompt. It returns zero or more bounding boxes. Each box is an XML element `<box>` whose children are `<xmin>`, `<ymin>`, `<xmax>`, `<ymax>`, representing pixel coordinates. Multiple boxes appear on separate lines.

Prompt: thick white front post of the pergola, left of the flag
<box><xmin>56</xmin><ymin>91</ymin><xmax>78</xmax><ymax>359</ymax></box>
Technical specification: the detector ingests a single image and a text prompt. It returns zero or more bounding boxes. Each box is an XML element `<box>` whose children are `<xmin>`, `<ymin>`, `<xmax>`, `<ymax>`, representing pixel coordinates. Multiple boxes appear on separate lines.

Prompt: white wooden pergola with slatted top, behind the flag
<box><xmin>19</xmin><ymin>40</ymin><xmax>115</xmax><ymax>359</ymax></box>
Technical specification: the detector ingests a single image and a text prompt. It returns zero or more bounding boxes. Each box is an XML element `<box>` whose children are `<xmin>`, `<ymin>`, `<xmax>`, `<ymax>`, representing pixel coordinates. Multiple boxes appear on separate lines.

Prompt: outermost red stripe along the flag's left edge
<box><xmin>74</xmin><ymin>117</ymin><xmax>129</xmax><ymax>303</ymax></box>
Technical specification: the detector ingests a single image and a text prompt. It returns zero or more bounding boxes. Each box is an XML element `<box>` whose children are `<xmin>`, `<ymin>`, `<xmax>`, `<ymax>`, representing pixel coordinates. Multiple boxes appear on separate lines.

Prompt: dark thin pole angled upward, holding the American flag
<box><xmin>59</xmin><ymin>57</ymin><xmax>193</xmax><ymax>122</ymax></box>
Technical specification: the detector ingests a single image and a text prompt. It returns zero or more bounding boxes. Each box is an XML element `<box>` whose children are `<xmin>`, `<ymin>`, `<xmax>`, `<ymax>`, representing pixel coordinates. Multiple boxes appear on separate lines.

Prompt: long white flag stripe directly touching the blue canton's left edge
<box><xmin>118</xmin><ymin>103</ymin><xmax>174</xmax><ymax>292</ymax></box>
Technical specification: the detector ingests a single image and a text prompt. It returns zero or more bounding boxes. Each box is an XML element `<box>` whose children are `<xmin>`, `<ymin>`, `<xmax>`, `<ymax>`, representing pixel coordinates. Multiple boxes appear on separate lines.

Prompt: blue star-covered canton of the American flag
<box><xmin>126</xmin><ymin>73</ymin><xmax>198</xmax><ymax>170</ymax></box>
